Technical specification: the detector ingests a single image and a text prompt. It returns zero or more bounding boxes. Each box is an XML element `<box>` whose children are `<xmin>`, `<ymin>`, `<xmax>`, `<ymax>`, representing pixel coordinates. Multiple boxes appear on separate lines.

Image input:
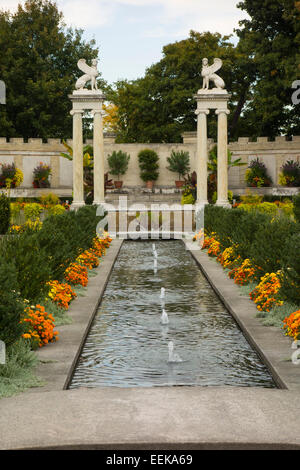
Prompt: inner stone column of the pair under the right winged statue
<box><xmin>196</xmin><ymin>109</ymin><xmax>209</xmax><ymax>205</ymax></box>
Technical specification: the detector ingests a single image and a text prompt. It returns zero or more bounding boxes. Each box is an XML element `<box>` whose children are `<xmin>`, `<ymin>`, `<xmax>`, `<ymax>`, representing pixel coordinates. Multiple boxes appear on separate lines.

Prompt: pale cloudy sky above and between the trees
<box><xmin>0</xmin><ymin>0</ymin><xmax>246</xmax><ymax>83</ymax></box>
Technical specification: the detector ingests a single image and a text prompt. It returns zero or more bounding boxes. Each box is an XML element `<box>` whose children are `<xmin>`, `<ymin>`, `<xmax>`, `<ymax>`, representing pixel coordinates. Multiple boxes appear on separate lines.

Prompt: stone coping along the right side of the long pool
<box><xmin>186</xmin><ymin>243</ymin><xmax>300</xmax><ymax>392</ymax></box>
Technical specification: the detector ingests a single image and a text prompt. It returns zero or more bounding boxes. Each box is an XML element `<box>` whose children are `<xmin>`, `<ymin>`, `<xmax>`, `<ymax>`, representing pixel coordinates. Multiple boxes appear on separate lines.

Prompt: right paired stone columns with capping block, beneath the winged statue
<box><xmin>195</xmin><ymin>88</ymin><xmax>231</xmax><ymax>206</ymax></box>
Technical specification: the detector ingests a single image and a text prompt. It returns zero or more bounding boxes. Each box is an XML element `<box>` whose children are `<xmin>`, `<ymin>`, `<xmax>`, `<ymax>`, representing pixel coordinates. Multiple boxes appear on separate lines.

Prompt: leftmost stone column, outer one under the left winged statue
<box><xmin>71</xmin><ymin>110</ymin><xmax>84</xmax><ymax>209</ymax></box>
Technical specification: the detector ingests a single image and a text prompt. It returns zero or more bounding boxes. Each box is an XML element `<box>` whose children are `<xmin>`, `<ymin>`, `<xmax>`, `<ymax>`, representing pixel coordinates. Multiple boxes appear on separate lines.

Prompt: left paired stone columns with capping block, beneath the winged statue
<box><xmin>69</xmin><ymin>89</ymin><xmax>105</xmax><ymax>209</ymax></box>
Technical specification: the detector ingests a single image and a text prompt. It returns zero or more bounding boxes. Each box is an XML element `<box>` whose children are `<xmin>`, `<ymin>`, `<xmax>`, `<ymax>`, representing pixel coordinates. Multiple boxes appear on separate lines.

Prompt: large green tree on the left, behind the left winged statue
<box><xmin>0</xmin><ymin>0</ymin><xmax>103</xmax><ymax>138</ymax></box>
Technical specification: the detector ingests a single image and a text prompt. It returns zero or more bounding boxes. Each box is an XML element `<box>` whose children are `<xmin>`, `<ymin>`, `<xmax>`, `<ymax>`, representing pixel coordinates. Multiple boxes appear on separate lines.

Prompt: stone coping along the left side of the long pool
<box><xmin>24</xmin><ymin>240</ymin><xmax>123</xmax><ymax>392</ymax></box>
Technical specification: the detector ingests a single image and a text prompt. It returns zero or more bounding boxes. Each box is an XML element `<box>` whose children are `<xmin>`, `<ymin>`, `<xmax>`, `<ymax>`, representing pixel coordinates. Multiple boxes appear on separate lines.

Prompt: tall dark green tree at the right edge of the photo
<box><xmin>237</xmin><ymin>0</ymin><xmax>300</xmax><ymax>137</ymax></box>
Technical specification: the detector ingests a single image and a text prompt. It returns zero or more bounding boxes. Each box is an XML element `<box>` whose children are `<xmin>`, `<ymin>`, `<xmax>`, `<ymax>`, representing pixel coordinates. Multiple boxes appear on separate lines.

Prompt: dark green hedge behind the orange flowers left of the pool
<box><xmin>0</xmin><ymin>206</ymin><xmax>101</xmax><ymax>302</ymax></box>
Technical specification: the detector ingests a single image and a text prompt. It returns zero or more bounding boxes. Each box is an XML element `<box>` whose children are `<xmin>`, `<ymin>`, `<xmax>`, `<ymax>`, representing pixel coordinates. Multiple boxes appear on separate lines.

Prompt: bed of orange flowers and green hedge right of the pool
<box><xmin>202</xmin><ymin>206</ymin><xmax>300</xmax><ymax>338</ymax></box>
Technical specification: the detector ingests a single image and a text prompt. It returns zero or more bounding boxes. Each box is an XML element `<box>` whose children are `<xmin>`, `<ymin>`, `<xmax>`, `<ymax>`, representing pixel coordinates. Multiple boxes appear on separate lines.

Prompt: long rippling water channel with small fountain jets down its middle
<box><xmin>70</xmin><ymin>241</ymin><xmax>276</xmax><ymax>389</ymax></box>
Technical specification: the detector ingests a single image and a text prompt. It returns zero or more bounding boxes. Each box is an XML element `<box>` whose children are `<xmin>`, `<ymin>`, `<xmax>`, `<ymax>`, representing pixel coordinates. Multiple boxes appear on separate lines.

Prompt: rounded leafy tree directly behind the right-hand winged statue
<box><xmin>110</xmin><ymin>31</ymin><xmax>253</xmax><ymax>142</ymax></box>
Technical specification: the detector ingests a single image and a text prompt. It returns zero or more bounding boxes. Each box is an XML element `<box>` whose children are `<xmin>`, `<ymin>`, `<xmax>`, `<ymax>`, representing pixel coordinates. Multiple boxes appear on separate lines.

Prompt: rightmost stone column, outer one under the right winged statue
<box><xmin>216</xmin><ymin>109</ymin><xmax>230</xmax><ymax>207</ymax></box>
